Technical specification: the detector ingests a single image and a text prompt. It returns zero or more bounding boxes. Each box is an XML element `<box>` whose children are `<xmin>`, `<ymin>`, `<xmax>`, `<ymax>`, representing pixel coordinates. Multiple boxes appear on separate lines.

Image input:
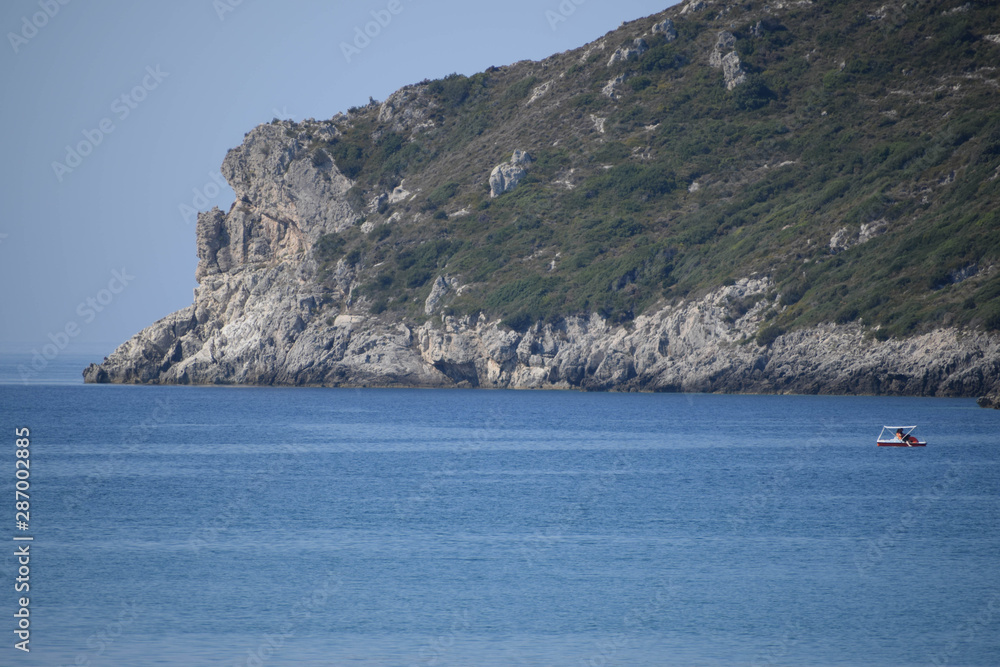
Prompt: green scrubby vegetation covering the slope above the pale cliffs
<box><xmin>302</xmin><ymin>0</ymin><xmax>1000</xmax><ymax>338</ymax></box>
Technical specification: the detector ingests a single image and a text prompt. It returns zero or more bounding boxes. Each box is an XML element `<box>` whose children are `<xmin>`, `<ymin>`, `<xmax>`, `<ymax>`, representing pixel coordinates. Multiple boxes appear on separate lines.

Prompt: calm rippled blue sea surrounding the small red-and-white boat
<box><xmin>0</xmin><ymin>358</ymin><xmax>1000</xmax><ymax>667</ymax></box>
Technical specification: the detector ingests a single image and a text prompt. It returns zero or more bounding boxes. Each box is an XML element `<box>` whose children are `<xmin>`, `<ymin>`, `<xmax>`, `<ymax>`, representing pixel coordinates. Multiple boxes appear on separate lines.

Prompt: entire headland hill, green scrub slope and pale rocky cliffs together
<box><xmin>87</xmin><ymin>0</ymin><xmax>1000</xmax><ymax>395</ymax></box>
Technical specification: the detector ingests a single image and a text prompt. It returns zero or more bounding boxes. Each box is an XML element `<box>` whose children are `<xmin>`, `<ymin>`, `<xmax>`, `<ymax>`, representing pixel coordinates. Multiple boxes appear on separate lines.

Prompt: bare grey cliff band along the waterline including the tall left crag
<box><xmin>85</xmin><ymin>148</ymin><xmax>1000</xmax><ymax>396</ymax></box>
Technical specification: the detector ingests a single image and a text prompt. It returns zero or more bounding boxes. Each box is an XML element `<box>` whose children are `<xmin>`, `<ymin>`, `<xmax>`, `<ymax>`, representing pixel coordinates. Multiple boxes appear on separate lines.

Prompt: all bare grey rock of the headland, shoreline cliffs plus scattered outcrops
<box><xmin>84</xmin><ymin>3</ymin><xmax>1000</xmax><ymax>407</ymax></box>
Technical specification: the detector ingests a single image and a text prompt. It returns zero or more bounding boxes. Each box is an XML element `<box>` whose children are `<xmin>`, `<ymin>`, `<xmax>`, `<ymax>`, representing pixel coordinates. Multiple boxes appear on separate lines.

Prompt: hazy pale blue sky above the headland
<box><xmin>0</xmin><ymin>0</ymin><xmax>673</xmax><ymax>354</ymax></box>
